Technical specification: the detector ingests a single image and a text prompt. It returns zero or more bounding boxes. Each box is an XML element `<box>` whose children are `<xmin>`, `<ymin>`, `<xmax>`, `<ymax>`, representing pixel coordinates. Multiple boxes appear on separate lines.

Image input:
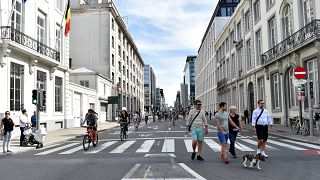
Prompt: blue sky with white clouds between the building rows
<box><xmin>115</xmin><ymin>0</ymin><xmax>218</xmax><ymax>106</ymax></box>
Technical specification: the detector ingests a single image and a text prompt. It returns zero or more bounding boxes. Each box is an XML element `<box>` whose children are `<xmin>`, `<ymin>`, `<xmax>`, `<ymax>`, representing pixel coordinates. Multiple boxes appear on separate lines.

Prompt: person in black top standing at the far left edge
<box><xmin>0</xmin><ymin>111</ymin><xmax>14</xmax><ymax>153</ymax></box>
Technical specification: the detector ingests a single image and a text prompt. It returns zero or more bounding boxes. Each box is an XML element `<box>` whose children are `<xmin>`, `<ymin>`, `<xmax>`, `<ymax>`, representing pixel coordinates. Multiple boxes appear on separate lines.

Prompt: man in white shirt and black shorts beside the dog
<box><xmin>252</xmin><ymin>100</ymin><xmax>273</xmax><ymax>158</ymax></box>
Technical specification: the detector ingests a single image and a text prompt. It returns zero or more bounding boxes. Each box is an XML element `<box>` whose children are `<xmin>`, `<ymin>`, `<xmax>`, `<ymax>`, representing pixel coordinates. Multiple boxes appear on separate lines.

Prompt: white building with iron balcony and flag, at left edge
<box><xmin>0</xmin><ymin>0</ymin><xmax>73</xmax><ymax>132</ymax></box>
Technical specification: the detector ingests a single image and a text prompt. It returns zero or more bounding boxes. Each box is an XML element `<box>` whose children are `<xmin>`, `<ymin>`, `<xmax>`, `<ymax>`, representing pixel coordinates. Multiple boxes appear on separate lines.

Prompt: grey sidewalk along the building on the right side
<box><xmin>242</xmin><ymin>122</ymin><xmax>320</xmax><ymax>145</ymax></box>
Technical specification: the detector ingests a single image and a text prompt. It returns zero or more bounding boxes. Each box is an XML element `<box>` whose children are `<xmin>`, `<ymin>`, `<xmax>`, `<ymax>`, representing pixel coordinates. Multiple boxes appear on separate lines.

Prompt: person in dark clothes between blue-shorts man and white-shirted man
<box><xmin>229</xmin><ymin>106</ymin><xmax>242</xmax><ymax>158</ymax></box>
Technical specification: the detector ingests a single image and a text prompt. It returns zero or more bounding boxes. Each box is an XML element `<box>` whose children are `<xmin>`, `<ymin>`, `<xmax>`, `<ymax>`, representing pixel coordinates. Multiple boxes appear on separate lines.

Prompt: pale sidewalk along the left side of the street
<box><xmin>0</xmin><ymin>122</ymin><xmax>119</xmax><ymax>156</ymax></box>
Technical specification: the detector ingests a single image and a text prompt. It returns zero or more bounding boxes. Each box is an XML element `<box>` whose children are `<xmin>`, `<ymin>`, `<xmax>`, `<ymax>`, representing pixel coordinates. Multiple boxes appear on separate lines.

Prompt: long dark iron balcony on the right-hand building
<box><xmin>261</xmin><ymin>19</ymin><xmax>320</xmax><ymax>65</ymax></box>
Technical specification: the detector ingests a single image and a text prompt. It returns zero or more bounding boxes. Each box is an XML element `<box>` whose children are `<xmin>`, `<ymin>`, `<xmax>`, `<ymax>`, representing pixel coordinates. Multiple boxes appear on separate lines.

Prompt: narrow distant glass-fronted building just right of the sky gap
<box><xmin>181</xmin><ymin>56</ymin><xmax>197</xmax><ymax>110</ymax></box>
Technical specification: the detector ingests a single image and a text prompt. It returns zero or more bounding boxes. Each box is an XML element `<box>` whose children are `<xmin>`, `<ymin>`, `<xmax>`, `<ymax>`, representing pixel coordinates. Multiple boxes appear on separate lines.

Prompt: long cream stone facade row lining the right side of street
<box><xmin>196</xmin><ymin>0</ymin><xmax>320</xmax><ymax>125</ymax></box>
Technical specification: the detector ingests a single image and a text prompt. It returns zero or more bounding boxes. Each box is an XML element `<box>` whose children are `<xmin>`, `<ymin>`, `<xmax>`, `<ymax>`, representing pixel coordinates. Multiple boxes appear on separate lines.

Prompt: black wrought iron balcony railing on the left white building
<box><xmin>0</xmin><ymin>26</ymin><xmax>60</xmax><ymax>62</ymax></box>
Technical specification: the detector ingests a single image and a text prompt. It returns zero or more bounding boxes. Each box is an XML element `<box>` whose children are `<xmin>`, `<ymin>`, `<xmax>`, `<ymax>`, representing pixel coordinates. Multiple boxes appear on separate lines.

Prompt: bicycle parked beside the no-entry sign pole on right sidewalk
<box><xmin>290</xmin><ymin>116</ymin><xmax>310</xmax><ymax>136</ymax></box>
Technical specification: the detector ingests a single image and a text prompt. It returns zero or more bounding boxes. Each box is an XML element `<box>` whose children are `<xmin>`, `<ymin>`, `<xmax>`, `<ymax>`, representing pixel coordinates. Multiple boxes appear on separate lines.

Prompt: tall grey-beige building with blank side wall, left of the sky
<box><xmin>70</xmin><ymin>0</ymin><xmax>144</xmax><ymax>119</ymax></box>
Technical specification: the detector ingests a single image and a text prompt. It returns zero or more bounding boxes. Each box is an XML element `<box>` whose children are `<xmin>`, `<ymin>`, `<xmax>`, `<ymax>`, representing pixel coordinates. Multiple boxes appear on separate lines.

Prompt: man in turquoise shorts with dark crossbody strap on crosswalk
<box><xmin>186</xmin><ymin>100</ymin><xmax>208</xmax><ymax>161</ymax></box>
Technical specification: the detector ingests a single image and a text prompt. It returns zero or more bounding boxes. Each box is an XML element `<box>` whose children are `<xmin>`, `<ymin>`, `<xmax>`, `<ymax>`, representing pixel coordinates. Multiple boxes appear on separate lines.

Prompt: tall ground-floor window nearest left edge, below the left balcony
<box><xmin>10</xmin><ymin>63</ymin><xmax>24</xmax><ymax>111</ymax></box>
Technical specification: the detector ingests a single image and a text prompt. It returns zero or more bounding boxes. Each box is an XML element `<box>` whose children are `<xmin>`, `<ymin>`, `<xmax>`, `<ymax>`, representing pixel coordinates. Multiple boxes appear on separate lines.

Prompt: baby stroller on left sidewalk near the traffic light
<box><xmin>22</xmin><ymin>125</ymin><xmax>47</xmax><ymax>149</ymax></box>
